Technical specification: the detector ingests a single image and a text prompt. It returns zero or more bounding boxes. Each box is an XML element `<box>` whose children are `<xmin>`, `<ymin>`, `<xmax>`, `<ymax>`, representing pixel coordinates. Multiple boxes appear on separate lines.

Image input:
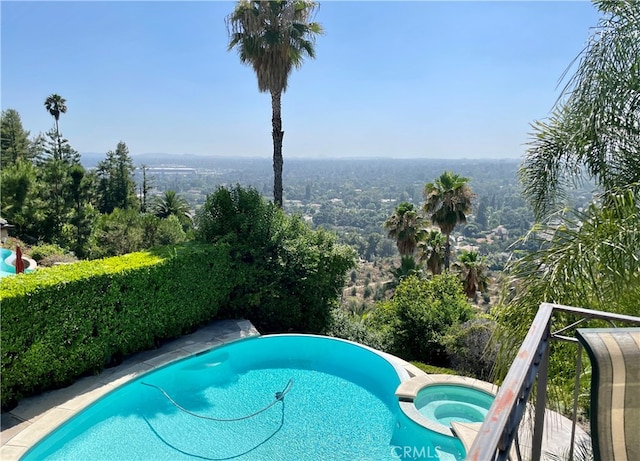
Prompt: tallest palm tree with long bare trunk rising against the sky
<box><xmin>227</xmin><ymin>0</ymin><xmax>322</xmax><ymax>208</ymax></box>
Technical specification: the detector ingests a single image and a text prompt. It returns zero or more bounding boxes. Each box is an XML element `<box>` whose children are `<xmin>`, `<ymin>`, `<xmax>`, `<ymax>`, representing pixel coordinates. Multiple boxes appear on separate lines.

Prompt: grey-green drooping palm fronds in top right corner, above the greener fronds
<box><xmin>520</xmin><ymin>0</ymin><xmax>640</xmax><ymax>219</ymax></box>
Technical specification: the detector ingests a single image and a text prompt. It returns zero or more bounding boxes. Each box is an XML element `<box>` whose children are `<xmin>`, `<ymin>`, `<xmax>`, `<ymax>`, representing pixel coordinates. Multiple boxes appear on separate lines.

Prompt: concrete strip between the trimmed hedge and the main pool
<box><xmin>0</xmin><ymin>319</ymin><xmax>260</xmax><ymax>461</ymax></box>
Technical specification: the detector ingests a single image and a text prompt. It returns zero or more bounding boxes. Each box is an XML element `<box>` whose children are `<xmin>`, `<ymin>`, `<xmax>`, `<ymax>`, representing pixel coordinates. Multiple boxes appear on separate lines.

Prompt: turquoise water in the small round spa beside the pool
<box><xmin>414</xmin><ymin>384</ymin><xmax>494</xmax><ymax>427</ymax></box>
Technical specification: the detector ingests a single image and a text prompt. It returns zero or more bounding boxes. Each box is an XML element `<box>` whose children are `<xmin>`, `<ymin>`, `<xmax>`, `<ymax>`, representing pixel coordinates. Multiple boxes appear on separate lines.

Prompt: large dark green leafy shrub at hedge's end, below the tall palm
<box><xmin>196</xmin><ymin>186</ymin><xmax>355</xmax><ymax>332</ymax></box>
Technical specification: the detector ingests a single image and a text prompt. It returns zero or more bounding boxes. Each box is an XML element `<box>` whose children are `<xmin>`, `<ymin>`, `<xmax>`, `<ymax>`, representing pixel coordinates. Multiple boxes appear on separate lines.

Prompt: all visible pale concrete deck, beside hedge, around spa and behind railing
<box><xmin>0</xmin><ymin>320</ymin><xmax>586</xmax><ymax>461</ymax></box>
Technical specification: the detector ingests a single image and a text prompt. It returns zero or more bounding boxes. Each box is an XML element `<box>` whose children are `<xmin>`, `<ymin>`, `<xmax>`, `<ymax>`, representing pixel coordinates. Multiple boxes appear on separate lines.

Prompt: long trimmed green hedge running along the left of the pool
<box><xmin>0</xmin><ymin>244</ymin><xmax>236</xmax><ymax>409</ymax></box>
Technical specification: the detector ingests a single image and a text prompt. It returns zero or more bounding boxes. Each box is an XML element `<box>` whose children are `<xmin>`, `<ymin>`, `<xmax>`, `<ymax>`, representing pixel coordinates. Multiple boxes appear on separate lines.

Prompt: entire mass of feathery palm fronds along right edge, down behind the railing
<box><xmin>495</xmin><ymin>0</ymin><xmax>640</xmax><ymax>416</ymax></box>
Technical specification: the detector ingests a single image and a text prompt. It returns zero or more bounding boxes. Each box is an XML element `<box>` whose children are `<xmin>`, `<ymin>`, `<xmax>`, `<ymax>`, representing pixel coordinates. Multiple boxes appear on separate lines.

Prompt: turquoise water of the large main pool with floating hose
<box><xmin>22</xmin><ymin>335</ymin><xmax>464</xmax><ymax>461</ymax></box>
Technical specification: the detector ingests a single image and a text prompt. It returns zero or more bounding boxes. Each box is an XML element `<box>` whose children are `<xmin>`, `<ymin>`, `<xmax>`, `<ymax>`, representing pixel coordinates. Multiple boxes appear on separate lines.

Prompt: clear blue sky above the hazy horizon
<box><xmin>0</xmin><ymin>0</ymin><xmax>599</xmax><ymax>159</ymax></box>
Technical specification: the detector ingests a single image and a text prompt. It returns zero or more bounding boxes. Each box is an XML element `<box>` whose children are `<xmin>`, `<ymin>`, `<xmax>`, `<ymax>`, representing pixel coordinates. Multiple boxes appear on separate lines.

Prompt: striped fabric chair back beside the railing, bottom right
<box><xmin>576</xmin><ymin>328</ymin><xmax>640</xmax><ymax>461</ymax></box>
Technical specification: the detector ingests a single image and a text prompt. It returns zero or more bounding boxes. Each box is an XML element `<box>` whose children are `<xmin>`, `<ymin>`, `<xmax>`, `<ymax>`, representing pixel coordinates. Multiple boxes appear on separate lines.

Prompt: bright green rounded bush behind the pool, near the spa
<box><xmin>370</xmin><ymin>274</ymin><xmax>473</xmax><ymax>365</ymax></box>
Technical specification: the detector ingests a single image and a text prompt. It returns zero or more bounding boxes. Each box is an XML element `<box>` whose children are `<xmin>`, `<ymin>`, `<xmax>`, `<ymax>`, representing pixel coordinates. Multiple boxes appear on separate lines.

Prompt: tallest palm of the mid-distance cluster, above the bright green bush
<box><xmin>423</xmin><ymin>171</ymin><xmax>474</xmax><ymax>270</ymax></box>
